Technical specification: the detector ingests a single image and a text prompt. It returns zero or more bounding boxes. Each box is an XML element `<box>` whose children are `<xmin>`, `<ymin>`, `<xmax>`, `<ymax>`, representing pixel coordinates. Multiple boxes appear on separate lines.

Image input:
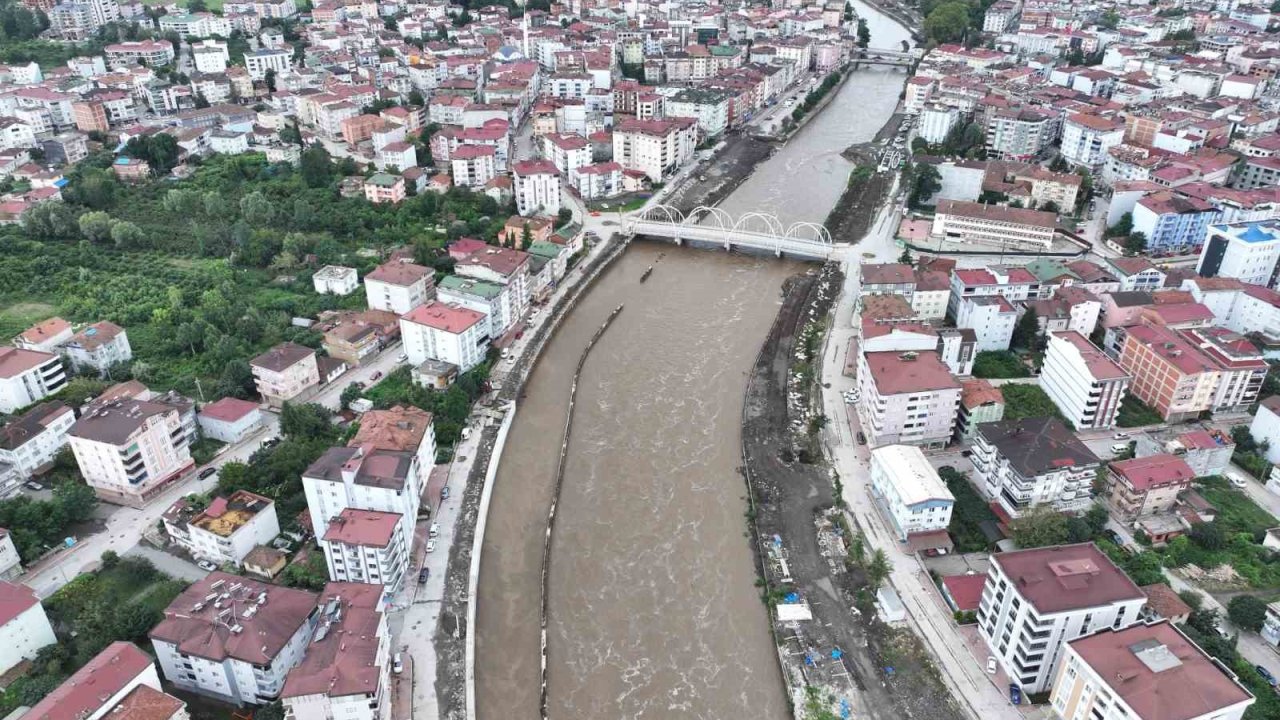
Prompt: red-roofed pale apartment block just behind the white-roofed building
<box><xmin>858</xmin><ymin>351</ymin><xmax>960</xmax><ymax>447</ymax></box>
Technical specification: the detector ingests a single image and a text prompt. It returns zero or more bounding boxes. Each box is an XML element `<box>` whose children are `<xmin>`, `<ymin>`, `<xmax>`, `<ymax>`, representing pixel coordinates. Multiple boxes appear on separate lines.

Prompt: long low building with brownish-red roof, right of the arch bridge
<box><xmin>929</xmin><ymin>200</ymin><xmax>1057</xmax><ymax>250</ymax></box>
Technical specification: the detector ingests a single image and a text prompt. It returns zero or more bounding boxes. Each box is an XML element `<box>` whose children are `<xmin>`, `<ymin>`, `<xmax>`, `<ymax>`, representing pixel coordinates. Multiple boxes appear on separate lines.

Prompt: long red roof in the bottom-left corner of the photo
<box><xmin>23</xmin><ymin>642</ymin><xmax>151</xmax><ymax>720</ymax></box>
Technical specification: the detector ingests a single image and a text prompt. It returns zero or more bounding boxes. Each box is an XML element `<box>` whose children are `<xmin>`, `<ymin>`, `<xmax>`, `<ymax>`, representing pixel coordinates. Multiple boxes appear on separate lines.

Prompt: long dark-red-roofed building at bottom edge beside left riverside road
<box><xmin>280</xmin><ymin>583</ymin><xmax>392</xmax><ymax>720</ymax></box>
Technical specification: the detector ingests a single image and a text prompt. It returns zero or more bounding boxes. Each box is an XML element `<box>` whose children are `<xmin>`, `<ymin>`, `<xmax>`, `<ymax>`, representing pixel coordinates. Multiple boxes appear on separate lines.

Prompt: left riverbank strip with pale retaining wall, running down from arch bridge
<box><xmin>434</xmin><ymin>233</ymin><xmax>627</xmax><ymax>719</ymax></box>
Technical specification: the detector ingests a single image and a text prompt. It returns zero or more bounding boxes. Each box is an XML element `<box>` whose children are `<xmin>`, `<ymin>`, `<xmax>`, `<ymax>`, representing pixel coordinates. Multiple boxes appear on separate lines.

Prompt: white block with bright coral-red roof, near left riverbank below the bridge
<box><xmin>401</xmin><ymin>302</ymin><xmax>489</xmax><ymax>373</ymax></box>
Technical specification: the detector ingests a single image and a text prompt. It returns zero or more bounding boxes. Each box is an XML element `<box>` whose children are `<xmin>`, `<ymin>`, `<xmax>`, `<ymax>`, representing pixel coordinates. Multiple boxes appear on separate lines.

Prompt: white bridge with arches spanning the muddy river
<box><xmin>625</xmin><ymin>205</ymin><xmax>833</xmax><ymax>260</ymax></box>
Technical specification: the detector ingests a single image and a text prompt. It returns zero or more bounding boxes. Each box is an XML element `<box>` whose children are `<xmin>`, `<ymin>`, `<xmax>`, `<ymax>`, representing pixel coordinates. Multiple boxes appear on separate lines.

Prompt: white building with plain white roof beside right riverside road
<box><xmin>872</xmin><ymin>445</ymin><xmax>955</xmax><ymax>541</ymax></box>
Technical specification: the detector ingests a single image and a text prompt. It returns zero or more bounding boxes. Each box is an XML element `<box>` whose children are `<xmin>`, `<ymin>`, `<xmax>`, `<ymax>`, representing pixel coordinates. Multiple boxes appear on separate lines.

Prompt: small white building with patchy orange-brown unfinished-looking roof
<box><xmin>187</xmin><ymin>489</ymin><xmax>280</xmax><ymax>566</ymax></box>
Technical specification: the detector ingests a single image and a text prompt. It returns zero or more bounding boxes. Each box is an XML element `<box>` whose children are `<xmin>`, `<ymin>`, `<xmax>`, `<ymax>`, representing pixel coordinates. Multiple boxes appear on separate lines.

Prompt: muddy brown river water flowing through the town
<box><xmin>475</xmin><ymin>0</ymin><xmax>908</xmax><ymax>720</ymax></box>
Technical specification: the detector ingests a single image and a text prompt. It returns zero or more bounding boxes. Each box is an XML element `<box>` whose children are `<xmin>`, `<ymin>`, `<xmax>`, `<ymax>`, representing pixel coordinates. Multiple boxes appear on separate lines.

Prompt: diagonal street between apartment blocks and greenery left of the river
<box><xmin>22</xmin><ymin>343</ymin><xmax>401</xmax><ymax>597</ymax></box>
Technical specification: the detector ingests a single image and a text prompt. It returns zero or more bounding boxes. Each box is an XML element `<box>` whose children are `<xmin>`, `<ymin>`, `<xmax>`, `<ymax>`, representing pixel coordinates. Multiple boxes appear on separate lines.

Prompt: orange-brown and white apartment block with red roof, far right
<box><xmin>1120</xmin><ymin>324</ymin><xmax>1219</xmax><ymax>421</ymax></box>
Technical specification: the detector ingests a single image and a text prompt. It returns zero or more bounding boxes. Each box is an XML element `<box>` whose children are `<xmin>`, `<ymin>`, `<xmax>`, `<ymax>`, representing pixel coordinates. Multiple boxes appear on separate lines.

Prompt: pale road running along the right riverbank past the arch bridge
<box><xmin>822</xmin><ymin>198</ymin><xmax>1021</xmax><ymax>720</ymax></box>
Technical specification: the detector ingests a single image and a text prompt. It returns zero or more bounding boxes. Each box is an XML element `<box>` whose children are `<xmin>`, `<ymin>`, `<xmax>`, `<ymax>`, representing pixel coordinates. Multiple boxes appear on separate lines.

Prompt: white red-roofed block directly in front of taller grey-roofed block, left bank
<box><xmin>320</xmin><ymin>507</ymin><xmax>408</xmax><ymax>593</ymax></box>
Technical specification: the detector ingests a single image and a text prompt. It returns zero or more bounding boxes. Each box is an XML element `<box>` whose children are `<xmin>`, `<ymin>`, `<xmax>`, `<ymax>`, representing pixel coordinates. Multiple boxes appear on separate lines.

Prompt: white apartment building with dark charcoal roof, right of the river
<box><xmin>970</xmin><ymin>418</ymin><xmax>1101</xmax><ymax>518</ymax></box>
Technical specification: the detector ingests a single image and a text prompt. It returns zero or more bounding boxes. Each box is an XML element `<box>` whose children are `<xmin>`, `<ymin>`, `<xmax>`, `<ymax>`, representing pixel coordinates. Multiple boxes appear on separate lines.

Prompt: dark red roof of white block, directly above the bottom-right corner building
<box><xmin>991</xmin><ymin>543</ymin><xmax>1146</xmax><ymax>615</ymax></box>
